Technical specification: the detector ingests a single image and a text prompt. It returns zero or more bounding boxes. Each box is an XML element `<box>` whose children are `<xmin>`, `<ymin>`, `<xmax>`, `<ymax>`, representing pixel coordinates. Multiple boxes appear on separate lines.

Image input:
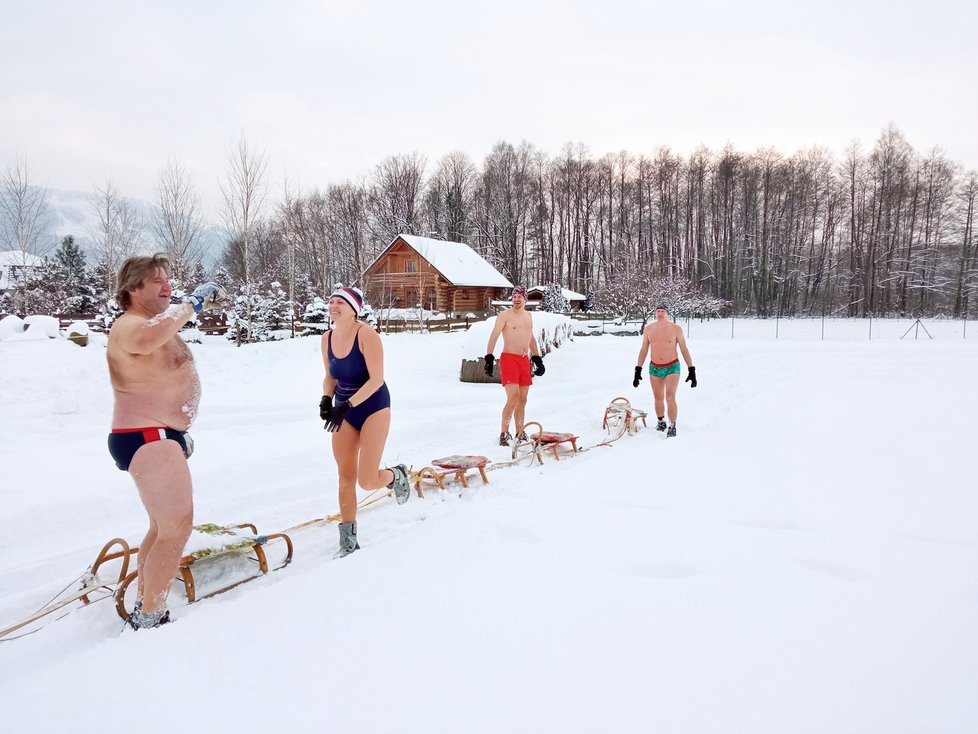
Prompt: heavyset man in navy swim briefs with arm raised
<box><xmin>106</xmin><ymin>254</ymin><xmax>226</xmax><ymax>629</ymax></box>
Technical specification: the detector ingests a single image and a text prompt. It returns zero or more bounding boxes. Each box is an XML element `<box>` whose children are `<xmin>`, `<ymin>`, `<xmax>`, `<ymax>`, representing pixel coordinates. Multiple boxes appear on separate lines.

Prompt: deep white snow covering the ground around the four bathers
<box><xmin>0</xmin><ymin>320</ymin><xmax>978</xmax><ymax>734</ymax></box>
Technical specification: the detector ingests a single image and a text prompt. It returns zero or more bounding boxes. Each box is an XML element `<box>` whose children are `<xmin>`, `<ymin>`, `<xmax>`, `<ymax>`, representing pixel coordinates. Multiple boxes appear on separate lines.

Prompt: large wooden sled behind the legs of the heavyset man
<box><xmin>112</xmin><ymin>523</ymin><xmax>293</xmax><ymax>619</ymax></box>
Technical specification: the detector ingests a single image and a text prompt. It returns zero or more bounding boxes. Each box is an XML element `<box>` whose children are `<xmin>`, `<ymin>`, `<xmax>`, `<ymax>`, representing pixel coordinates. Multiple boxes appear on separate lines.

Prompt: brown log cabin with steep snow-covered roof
<box><xmin>363</xmin><ymin>234</ymin><xmax>513</xmax><ymax>313</ymax></box>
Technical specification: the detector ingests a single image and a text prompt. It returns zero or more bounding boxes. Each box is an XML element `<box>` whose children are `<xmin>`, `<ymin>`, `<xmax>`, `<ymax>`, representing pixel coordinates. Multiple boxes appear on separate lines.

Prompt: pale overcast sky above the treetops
<box><xmin>0</xmin><ymin>0</ymin><xmax>978</xmax><ymax>218</ymax></box>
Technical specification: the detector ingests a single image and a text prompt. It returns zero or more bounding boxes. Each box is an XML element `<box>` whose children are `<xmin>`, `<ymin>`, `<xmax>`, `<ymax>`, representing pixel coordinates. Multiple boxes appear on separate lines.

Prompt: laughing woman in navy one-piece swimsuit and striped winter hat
<box><xmin>319</xmin><ymin>288</ymin><xmax>411</xmax><ymax>557</ymax></box>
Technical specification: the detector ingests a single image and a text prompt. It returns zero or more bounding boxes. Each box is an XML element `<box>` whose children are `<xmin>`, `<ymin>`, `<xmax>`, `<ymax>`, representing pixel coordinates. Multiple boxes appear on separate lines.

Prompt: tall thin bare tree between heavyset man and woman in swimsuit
<box><xmin>221</xmin><ymin>133</ymin><xmax>268</xmax><ymax>345</ymax></box>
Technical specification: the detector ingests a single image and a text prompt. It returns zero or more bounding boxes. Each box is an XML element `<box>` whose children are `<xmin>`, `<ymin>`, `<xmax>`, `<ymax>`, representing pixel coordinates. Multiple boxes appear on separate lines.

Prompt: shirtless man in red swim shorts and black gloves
<box><xmin>485</xmin><ymin>285</ymin><xmax>546</xmax><ymax>446</ymax></box>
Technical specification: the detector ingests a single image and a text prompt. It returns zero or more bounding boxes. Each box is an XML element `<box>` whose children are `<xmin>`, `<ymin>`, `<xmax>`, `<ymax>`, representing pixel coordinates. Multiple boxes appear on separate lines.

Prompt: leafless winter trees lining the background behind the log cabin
<box><xmin>8</xmin><ymin>126</ymin><xmax>978</xmax><ymax>317</ymax></box>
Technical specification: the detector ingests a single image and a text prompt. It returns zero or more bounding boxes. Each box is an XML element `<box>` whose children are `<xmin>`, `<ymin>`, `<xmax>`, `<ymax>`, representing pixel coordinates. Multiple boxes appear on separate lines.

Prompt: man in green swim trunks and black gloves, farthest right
<box><xmin>632</xmin><ymin>305</ymin><xmax>696</xmax><ymax>437</ymax></box>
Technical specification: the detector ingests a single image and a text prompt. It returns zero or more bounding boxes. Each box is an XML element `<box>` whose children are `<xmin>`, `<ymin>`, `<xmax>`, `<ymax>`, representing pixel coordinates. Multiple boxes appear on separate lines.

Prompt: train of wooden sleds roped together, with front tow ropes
<box><xmin>0</xmin><ymin>397</ymin><xmax>647</xmax><ymax>642</ymax></box>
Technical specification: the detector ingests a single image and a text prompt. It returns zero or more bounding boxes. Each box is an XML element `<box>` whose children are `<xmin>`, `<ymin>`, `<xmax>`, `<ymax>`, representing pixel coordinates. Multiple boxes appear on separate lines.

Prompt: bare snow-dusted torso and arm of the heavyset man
<box><xmin>107</xmin><ymin>307</ymin><xmax>200</xmax><ymax>431</ymax></box>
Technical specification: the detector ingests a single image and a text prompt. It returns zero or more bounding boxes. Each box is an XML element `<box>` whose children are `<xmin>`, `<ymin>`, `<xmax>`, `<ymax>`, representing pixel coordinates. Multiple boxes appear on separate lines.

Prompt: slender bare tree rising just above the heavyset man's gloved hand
<box><xmin>153</xmin><ymin>160</ymin><xmax>204</xmax><ymax>286</ymax></box>
